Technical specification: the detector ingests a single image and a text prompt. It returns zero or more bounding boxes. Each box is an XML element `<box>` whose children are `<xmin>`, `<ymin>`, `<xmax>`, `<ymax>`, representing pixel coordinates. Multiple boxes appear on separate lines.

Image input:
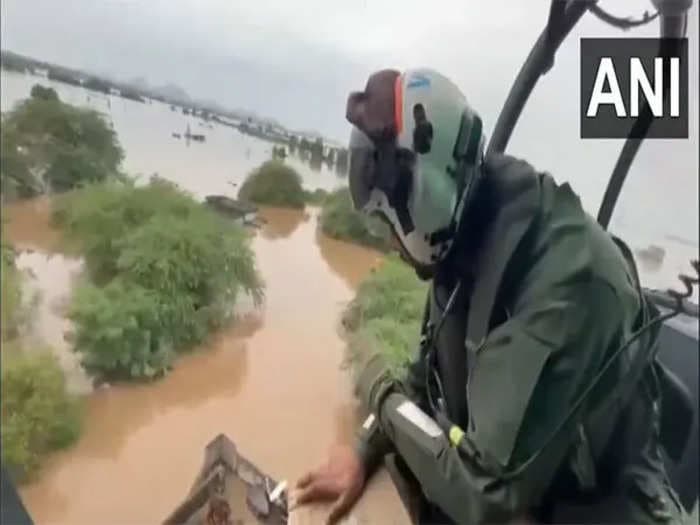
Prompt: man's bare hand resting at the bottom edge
<box><xmin>292</xmin><ymin>445</ymin><xmax>366</xmax><ymax>523</ymax></box>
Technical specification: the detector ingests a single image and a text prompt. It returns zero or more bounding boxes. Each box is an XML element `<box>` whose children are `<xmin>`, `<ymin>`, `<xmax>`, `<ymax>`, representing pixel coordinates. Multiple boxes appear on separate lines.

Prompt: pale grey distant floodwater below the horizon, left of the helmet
<box><xmin>0</xmin><ymin>71</ymin><xmax>344</xmax><ymax>197</ymax></box>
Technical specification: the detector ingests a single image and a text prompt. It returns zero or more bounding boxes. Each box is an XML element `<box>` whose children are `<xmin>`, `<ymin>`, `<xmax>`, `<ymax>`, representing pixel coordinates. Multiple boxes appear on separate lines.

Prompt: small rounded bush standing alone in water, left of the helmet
<box><xmin>238</xmin><ymin>160</ymin><xmax>305</xmax><ymax>209</ymax></box>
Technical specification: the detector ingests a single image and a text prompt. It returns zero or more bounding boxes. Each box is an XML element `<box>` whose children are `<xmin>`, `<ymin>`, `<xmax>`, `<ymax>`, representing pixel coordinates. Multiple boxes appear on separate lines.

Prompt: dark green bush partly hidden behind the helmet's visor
<box><xmin>320</xmin><ymin>188</ymin><xmax>390</xmax><ymax>250</ymax></box>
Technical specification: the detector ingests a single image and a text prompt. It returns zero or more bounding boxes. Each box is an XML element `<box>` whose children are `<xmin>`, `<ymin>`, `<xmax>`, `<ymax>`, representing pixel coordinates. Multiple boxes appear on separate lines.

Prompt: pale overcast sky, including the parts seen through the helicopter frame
<box><xmin>1</xmin><ymin>0</ymin><xmax>698</xmax><ymax>239</ymax></box>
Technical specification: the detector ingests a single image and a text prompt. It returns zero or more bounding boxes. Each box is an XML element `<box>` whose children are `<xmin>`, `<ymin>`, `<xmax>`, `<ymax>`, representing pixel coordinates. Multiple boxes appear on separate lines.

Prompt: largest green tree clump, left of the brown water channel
<box><xmin>53</xmin><ymin>179</ymin><xmax>262</xmax><ymax>380</ymax></box>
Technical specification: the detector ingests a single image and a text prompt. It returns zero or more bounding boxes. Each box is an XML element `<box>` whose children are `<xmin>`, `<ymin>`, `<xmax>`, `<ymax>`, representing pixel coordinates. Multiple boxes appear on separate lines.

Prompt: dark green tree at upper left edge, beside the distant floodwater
<box><xmin>0</xmin><ymin>85</ymin><xmax>124</xmax><ymax>199</ymax></box>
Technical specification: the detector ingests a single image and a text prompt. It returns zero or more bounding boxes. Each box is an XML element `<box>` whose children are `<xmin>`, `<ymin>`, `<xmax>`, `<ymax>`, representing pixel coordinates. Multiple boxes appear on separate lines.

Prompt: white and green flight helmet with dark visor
<box><xmin>347</xmin><ymin>69</ymin><xmax>484</xmax><ymax>269</ymax></box>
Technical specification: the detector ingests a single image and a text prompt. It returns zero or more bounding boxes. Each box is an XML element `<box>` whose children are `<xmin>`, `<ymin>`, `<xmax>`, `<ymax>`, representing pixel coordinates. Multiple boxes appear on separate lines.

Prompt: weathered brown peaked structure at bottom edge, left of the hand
<box><xmin>163</xmin><ymin>434</ymin><xmax>289</xmax><ymax>525</ymax></box>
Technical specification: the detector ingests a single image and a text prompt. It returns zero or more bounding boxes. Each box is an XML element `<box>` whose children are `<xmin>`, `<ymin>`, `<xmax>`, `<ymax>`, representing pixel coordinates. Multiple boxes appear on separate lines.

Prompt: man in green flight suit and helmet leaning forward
<box><xmin>293</xmin><ymin>69</ymin><xmax>683</xmax><ymax>524</ymax></box>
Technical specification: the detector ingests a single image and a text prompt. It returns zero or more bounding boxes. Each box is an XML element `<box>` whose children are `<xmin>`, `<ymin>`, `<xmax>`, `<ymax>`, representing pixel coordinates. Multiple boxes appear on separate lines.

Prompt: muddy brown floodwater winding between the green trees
<box><xmin>6</xmin><ymin>201</ymin><xmax>405</xmax><ymax>525</ymax></box>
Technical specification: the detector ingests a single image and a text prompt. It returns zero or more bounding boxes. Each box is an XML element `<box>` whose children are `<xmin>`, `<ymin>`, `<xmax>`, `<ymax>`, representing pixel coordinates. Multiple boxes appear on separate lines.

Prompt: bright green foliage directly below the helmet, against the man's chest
<box><xmin>344</xmin><ymin>256</ymin><xmax>428</xmax><ymax>377</ymax></box>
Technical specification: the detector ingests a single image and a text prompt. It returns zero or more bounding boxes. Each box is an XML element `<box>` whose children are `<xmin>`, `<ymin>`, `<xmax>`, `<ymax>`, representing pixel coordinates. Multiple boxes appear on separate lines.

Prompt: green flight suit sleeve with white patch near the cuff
<box><xmin>372</xmin><ymin>280</ymin><xmax>633</xmax><ymax>524</ymax></box>
